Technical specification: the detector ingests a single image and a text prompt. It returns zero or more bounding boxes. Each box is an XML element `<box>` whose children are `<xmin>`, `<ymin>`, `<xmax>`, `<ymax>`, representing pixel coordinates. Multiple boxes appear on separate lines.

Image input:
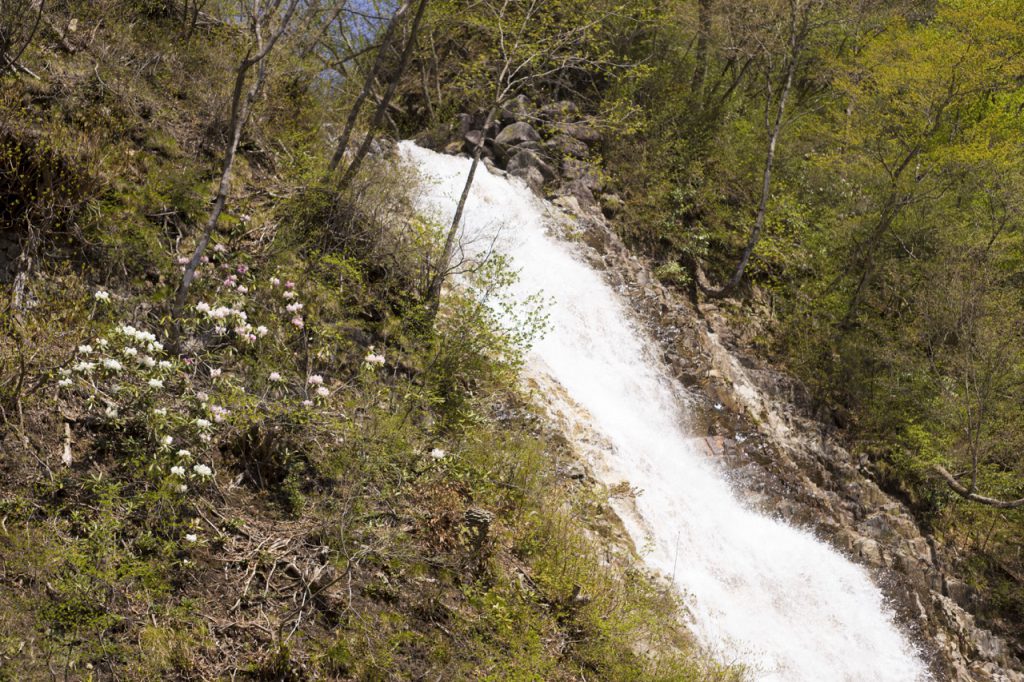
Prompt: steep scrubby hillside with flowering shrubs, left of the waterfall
<box><xmin>0</xmin><ymin>0</ymin><xmax>735</xmax><ymax>680</ymax></box>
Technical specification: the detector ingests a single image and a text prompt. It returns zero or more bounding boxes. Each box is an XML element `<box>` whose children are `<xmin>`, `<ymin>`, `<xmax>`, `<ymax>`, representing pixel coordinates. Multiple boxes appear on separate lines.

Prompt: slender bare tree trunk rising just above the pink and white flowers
<box><xmin>171</xmin><ymin>0</ymin><xmax>299</xmax><ymax>319</ymax></box>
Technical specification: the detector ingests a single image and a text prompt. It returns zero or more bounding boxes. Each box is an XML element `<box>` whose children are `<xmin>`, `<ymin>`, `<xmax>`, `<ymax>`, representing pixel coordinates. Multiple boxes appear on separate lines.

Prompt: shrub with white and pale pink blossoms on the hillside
<box><xmin>56</xmin><ymin>258</ymin><xmax>360</xmax><ymax>544</ymax></box>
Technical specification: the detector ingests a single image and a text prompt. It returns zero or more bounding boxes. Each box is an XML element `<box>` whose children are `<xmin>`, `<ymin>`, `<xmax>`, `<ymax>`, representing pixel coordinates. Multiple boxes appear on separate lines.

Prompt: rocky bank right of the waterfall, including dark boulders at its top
<box><xmin>430</xmin><ymin>100</ymin><xmax>1024</xmax><ymax>682</ymax></box>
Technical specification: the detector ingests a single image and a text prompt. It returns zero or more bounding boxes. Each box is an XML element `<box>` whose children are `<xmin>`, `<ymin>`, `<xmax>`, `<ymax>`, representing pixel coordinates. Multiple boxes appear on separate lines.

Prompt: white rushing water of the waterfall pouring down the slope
<box><xmin>401</xmin><ymin>142</ymin><xmax>929</xmax><ymax>682</ymax></box>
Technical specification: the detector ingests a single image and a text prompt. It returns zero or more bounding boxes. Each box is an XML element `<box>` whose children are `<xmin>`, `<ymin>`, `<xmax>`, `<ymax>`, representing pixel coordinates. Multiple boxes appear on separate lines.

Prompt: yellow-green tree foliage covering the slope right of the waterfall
<box><xmin>605</xmin><ymin>0</ymin><xmax>1024</xmax><ymax>635</ymax></box>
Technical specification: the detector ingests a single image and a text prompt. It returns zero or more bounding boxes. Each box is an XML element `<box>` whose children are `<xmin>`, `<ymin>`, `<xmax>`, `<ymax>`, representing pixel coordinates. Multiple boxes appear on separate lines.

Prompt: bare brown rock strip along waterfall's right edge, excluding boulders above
<box><xmin>586</xmin><ymin>216</ymin><xmax>1024</xmax><ymax>682</ymax></box>
